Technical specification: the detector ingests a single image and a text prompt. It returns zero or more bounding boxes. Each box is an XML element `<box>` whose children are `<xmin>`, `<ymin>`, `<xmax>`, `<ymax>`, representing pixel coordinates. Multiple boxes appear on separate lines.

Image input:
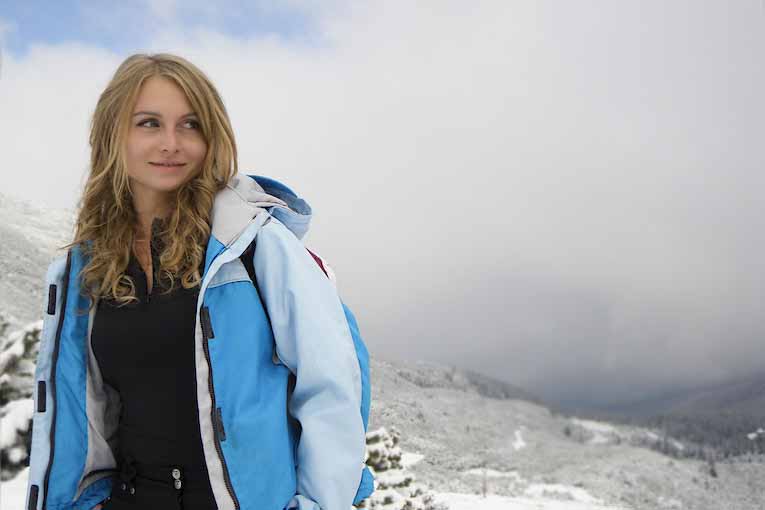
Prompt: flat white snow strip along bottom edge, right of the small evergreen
<box><xmin>433</xmin><ymin>492</ymin><xmax>628</xmax><ymax>510</ymax></box>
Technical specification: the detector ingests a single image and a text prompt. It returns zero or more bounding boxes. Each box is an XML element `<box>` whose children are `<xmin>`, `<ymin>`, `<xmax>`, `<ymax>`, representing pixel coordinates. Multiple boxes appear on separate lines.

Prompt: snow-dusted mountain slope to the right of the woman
<box><xmin>370</xmin><ymin>353</ymin><xmax>765</xmax><ymax>510</ymax></box>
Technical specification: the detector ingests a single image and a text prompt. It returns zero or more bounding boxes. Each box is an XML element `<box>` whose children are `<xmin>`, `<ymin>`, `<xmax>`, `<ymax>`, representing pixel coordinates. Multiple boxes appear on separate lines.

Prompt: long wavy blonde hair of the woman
<box><xmin>62</xmin><ymin>53</ymin><xmax>238</xmax><ymax>307</ymax></box>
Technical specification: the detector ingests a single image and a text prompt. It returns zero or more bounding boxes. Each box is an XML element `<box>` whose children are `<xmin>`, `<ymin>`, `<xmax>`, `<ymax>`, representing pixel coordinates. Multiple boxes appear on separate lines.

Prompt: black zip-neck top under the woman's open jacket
<box><xmin>91</xmin><ymin>229</ymin><xmax>211</xmax><ymax>480</ymax></box>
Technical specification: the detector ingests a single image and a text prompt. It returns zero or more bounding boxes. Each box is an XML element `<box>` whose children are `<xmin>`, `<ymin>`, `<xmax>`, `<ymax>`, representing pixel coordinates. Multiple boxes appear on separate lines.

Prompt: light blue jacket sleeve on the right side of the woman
<box><xmin>253</xmin><ymin>217</ymin><xmax>366</xmax><ymax>510</ymax></box>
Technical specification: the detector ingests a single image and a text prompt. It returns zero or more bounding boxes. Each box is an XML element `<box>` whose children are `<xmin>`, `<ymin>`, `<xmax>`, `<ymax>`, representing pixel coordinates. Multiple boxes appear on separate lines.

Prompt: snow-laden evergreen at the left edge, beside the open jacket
<box><xmin>0</xmin><ymin>316</ymin><xmax>42</xmax><ymax>480</ymax></box>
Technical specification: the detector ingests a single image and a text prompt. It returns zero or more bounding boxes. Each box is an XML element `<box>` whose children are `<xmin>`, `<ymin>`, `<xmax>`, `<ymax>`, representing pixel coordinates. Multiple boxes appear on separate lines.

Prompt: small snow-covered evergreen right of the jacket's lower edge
<box><xmin>358</xmin><ymin>427</ymin><xmax>447</xmax><ymax>510</ymax></box>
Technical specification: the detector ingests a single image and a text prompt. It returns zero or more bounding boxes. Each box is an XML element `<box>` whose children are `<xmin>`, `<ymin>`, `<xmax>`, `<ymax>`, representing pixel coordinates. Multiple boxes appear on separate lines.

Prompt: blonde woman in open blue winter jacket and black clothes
<box><xmin>27</xmin><ymin>54</ymin><xmax>373</xmax><ymax>510</ymax></box>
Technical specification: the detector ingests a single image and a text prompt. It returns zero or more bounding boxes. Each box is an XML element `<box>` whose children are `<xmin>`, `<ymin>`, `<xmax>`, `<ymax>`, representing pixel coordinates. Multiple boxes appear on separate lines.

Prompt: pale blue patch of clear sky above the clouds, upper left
<box><xmin>0</xmin><ymin>0</ymin><xmax>318</xmax><ymax>56</ymax></box>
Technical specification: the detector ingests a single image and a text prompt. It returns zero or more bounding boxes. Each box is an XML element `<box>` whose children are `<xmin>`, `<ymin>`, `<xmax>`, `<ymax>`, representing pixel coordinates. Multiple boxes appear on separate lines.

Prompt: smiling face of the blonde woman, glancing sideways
<box><xmin>126</xmin><ymin>76</ymin><xmax>207</xmax><ymax>201</ymax></box>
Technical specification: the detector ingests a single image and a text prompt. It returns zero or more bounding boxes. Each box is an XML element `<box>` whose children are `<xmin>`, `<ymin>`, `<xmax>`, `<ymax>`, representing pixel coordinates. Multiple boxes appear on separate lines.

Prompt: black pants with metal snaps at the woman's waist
<box><xmin>103</xmin><ymin>457</ymin><xmax>217</xmax><ymax>510</ymax></box>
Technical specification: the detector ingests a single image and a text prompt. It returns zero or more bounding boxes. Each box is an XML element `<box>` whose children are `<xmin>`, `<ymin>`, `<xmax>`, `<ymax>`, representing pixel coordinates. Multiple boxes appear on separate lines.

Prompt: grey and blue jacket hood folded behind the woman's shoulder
<box><xmin>211</xmin><ymin>173</ymin><xmax>312</xmax><ymax>246</ymax></box>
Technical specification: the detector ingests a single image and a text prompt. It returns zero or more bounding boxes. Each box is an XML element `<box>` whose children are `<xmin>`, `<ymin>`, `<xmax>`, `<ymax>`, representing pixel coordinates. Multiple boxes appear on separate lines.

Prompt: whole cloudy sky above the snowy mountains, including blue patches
<box><xmin>0</xmin><ymin>0</ymin><xmax>765</xmax><ymax>404</ymax></box>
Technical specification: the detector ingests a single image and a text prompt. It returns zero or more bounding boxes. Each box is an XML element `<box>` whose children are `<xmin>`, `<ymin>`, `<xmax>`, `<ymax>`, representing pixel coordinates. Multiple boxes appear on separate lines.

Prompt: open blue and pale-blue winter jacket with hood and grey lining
<box><xmin>27</xmin><ymin>173</ymin><xmax>373</xmax><ymax>510</ymax></box>
